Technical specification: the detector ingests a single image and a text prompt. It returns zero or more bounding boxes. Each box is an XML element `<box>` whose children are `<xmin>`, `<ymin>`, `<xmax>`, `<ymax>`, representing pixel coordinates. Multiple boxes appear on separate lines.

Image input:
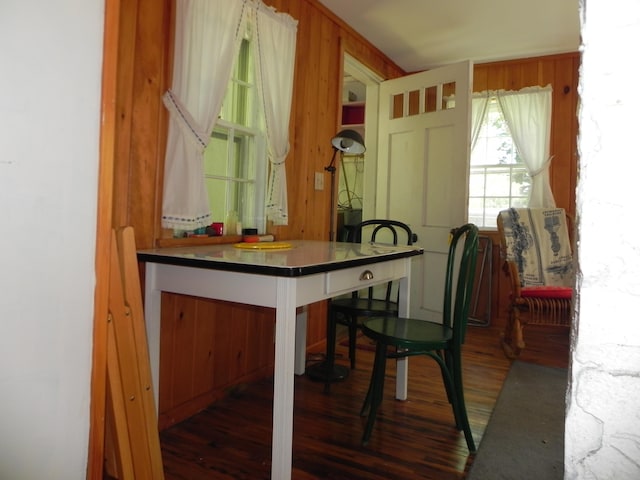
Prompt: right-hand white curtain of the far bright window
<box><xmin>497</xmin><ymin>85</ymin><xmax>556</xmax><ymax>208</ymax></box>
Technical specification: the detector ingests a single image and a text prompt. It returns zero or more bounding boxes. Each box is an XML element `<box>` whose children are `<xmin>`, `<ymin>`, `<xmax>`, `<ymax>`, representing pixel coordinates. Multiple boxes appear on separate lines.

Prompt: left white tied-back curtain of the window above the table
<box><xmin>162</xmin><ymin>0</ymin><xmax>247</xmax><ymax>230</ymax></box>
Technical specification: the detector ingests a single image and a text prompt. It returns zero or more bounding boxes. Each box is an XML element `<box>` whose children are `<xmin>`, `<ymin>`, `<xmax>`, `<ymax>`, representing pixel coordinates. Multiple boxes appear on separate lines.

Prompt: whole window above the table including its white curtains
<box><xmin>161</xmin><ymin>0</ymin><xmax>298</xmax><ymax>236</ymax></box>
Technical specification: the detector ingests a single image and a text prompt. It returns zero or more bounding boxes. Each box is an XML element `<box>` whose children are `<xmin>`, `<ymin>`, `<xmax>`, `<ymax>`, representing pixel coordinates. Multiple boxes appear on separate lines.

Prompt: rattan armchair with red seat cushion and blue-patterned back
<box><xmin>497</xmin><ymin>208</ymin><xmax>574</xmax><ymax>358</ymax></box>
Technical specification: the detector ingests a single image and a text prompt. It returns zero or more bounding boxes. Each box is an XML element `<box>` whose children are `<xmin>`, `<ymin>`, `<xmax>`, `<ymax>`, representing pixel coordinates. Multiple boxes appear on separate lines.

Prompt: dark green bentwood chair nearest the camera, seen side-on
<box><xmin>360</xmin><ymin>224</ymin><xmax>478</xmax><ymax>452</ymax></box>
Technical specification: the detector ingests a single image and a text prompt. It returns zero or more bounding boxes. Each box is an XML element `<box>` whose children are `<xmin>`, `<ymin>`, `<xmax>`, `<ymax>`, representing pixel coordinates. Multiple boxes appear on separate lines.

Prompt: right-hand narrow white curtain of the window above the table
<box><xmin>256</xmin><ymin>5</ymin><xmax>298</xmax><ymax>225</ymax></box>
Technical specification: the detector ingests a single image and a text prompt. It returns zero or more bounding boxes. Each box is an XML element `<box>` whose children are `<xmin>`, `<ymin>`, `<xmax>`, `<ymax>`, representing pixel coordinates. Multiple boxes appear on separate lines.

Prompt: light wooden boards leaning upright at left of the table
<box><xmin>105</xmin><ymin>227</ymin><xmax>164</xmax><ymax>480</ymax></box>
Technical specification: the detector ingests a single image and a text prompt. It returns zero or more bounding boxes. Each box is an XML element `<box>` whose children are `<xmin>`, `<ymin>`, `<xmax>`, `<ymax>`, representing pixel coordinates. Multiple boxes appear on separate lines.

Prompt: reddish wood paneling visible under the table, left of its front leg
<box><xmin>158</xmin><ymin>294</ymin><xmax>275</xmax><ymax>429</ymax></box>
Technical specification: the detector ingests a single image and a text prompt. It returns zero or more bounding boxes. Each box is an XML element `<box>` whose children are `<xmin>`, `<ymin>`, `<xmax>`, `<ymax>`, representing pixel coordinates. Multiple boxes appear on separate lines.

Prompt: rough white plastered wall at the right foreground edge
<box><xmin>565</xmin><ymin>0</ymin><xmax>640</xmax><ymax>480</ymax></box>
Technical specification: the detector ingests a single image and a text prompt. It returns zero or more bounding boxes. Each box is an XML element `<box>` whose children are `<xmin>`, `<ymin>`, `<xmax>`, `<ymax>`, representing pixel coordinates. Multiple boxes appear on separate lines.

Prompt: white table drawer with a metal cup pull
<box><xmin>325</xmin><ymin>260</ymin><xmax>406</xmax><ymax>295</ymax></box>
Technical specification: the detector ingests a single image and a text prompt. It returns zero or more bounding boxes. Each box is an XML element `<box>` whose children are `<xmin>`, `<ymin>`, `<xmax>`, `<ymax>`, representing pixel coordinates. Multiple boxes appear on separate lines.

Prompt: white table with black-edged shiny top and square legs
<box><xmin>138</xmin><ymin>240</ymin><xmax>423</xmax><ymax>480</ymax></box>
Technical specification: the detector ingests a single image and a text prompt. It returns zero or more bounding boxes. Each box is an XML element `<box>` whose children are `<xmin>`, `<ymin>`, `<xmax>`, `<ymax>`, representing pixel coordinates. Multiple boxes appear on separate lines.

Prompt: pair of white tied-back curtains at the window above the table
<box><xmin>162</xmin><ymin>0</ymin><xmax>297</xmax><ymax>230</ymax></box>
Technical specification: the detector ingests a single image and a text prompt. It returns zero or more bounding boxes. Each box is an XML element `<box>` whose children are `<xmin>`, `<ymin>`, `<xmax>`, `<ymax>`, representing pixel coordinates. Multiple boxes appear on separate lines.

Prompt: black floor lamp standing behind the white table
<box><xmin>307</xmin><ymin>130</ymin><xmax>366</xmax><ymax>383</ymax></box>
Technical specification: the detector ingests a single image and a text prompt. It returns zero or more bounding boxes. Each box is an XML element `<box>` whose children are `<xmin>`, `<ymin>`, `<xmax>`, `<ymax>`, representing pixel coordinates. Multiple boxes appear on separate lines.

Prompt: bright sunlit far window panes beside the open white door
<box><xmin>469</xmin><ymin>98</ymin><xmax>531</xmax><ymax>228</ymax></box>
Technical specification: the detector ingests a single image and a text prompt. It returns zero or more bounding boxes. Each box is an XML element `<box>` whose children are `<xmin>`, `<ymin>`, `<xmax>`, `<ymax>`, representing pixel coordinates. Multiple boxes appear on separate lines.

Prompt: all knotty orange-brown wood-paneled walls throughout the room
<box><xmin>113</xmin><ymin>0</ymin><xmax>578</xmax><ymax>432</ymax></box>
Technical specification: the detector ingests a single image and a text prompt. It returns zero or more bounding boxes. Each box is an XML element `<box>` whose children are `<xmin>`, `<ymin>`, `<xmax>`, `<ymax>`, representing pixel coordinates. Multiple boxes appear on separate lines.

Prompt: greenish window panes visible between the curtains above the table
<box><xmin>204</xmin><ymin>38</ymin><xmax>267</xmax><ymax>234</ymax></box>
